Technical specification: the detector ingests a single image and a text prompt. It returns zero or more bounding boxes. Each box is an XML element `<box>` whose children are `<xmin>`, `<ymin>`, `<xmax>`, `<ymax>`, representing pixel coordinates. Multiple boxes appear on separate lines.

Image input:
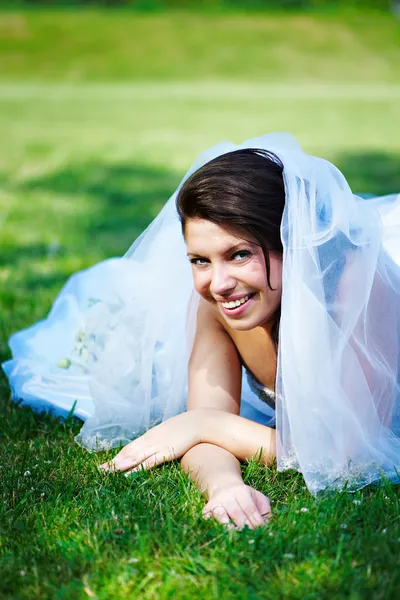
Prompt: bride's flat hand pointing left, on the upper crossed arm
<box><xmin>99</xmin><ymin>410</ymin><xmax>202</xmax><ymax>475</ymax></box>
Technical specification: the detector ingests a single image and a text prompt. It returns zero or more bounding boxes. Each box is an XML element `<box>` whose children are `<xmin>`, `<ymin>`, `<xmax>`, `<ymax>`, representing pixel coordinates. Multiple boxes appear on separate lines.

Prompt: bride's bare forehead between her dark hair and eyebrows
<box><xmin>185</xmin><ymin>219</ymin><xmax>252</xmax><ymax>254</ymax></box>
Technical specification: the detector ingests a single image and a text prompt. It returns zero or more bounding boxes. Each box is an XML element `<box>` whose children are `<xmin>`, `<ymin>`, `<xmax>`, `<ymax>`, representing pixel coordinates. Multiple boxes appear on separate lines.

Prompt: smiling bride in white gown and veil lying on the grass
<box><xmin>3</xmin><ymin>134</ymin><xmax>400</xmax><ymax>528</ymax></box>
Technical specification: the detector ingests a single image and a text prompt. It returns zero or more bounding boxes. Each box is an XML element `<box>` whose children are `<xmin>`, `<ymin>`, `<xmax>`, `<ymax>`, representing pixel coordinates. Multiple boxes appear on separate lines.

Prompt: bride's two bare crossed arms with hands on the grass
<box><xmin>100</xmin><ymin>298</ymin><xmax>274</xmax><ymax>527</ymax></box>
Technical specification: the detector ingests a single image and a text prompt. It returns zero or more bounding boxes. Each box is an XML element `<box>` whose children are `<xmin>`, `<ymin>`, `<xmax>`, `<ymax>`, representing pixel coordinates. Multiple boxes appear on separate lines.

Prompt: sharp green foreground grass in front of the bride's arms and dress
<box><xmin>1</xmin><ymin>404</ymin><xmax>400</xmax><ymax>600</ymax></box>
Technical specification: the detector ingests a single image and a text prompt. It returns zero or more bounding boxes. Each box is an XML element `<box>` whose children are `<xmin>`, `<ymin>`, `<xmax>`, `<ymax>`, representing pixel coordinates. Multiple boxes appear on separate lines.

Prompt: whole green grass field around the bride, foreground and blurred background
<box><xmin>0</xmin><ymin>11</ymin><xmax>400</xmax><ymax>600</ymax></box>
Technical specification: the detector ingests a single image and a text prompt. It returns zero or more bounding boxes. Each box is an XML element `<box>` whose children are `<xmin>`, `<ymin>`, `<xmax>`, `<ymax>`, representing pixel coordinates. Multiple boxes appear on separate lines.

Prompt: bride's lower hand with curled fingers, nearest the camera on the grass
<box><xmin>203</xmin><ymin>482</ymin><xmax>271</xmax><ymax>529</ymax></box>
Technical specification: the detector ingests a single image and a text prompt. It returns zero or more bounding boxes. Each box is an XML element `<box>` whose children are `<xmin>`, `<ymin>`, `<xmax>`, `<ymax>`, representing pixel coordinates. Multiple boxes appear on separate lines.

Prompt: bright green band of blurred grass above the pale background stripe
<box><xmin>0</xmin><ymin>10</ymin><xmax>400</xmax><ymax>85</ymax></box>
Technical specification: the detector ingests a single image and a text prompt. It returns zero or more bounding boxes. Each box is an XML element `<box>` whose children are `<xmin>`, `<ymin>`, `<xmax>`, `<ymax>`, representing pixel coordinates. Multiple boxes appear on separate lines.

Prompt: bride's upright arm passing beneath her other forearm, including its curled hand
<box><xmin>181</xmin><ymin>300</ymin><xmax>270</xmax><ymax>527</ymax></box>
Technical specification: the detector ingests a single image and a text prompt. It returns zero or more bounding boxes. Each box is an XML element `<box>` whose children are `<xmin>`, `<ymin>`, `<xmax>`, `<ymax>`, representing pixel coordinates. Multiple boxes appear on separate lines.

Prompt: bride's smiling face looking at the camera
<box><xmin>185</xmin><ymin>219</ymin><xmax>282</xmax><ymax>331</ymax></box>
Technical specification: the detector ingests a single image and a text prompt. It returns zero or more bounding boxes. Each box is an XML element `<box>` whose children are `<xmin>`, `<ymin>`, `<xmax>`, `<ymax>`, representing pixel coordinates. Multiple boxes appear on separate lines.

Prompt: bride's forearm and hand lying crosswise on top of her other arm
<box><xmin>101</xmin><ymin>408</ymin><xmax>276</xmax><ymax>472</ymax></box>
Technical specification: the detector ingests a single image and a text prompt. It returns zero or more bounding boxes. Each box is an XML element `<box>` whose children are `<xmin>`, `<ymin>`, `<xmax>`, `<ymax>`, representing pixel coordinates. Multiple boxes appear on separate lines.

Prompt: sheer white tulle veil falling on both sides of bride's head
<box><xmin>3</xmin><ymin>134</ymin><xmax>400</xmax><ymax>493</ymax></box>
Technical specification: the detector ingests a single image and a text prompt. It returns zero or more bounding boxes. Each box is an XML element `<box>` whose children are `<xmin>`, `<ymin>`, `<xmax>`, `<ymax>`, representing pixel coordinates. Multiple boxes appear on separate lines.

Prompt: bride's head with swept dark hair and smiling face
<box><xmin>177</xmin><ymin>149</ymin><xmax>285</xmax><ymax>338</ymax></box>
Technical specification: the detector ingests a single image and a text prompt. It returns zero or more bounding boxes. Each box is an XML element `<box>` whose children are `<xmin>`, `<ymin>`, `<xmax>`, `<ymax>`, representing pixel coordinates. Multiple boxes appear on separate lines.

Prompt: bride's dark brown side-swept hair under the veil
<box><xmin>176</xmin><ymin>148</ymin><xmax>285</xmax><ymax>344</ymax></box>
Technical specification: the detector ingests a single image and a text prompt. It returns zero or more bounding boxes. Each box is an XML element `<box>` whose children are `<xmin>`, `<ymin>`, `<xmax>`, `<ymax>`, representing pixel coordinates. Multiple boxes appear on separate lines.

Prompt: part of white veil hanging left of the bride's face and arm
<box><xmin>76</xmin><ymin>142</ymin><xmax>236</xmax><ymax>450</ymax></box>
